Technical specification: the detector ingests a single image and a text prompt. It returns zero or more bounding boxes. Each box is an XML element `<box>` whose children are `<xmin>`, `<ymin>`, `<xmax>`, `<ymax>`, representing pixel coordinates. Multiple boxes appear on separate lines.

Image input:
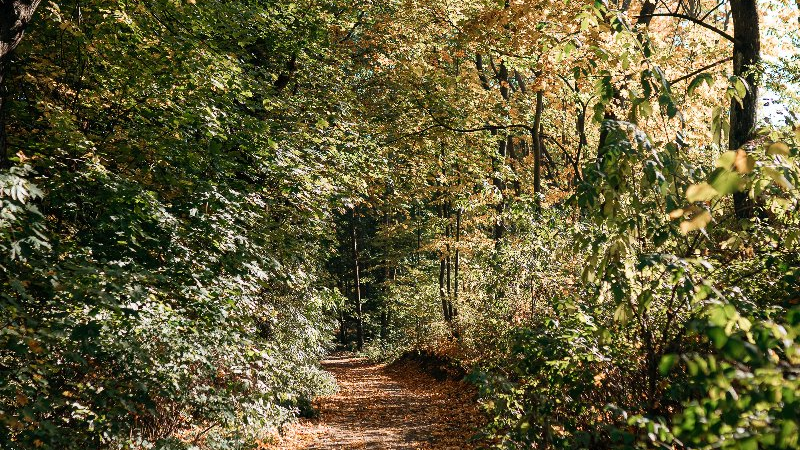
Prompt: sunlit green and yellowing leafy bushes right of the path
<box><xmin>474</xmin><ymin>118</ymin><xmax>800</xmax><ymax>449</ymax></box>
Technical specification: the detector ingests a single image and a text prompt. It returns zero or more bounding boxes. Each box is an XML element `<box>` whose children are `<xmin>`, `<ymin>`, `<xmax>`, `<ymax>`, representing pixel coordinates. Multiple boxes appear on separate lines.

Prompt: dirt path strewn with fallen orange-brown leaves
<box><xmin>272</xmin><ymin>354</ymin><xmax>482</xmax><ymax>450</ymax></box>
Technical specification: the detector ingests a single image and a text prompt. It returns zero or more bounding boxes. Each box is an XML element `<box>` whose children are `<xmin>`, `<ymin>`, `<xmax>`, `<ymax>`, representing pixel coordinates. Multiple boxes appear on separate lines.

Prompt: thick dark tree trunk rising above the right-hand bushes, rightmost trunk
<box><xmin>729</xmin><ymin>0</ymin><xmax>761</xmax><ymax>219</ymax></box>
